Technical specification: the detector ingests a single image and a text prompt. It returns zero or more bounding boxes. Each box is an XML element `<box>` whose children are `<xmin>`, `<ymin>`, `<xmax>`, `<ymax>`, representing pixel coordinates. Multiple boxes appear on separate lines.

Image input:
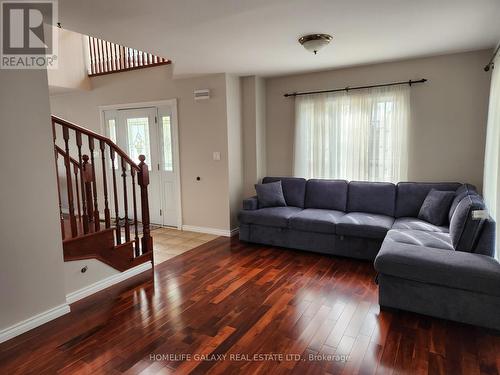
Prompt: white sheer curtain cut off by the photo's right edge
<box><xmin>483</xmin><ymin>56</ymin><xmax>500</xmax><ymax>260</ymax></box>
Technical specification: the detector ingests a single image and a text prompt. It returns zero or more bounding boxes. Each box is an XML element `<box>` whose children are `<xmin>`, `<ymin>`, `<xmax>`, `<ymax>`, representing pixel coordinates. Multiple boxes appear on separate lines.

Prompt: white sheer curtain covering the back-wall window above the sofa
<box><xmin>294</xmin><ymin>85</ymin><xmax>410</xmax><ymax>182</ymax></box>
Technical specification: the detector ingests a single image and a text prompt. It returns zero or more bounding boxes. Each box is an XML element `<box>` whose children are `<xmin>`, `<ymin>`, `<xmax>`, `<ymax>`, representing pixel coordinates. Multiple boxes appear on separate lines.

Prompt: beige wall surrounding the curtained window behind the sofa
<box><xmin>267</xmin><ymin>50</ymin><xmax>491</xmax><ymax>188</ymax></box>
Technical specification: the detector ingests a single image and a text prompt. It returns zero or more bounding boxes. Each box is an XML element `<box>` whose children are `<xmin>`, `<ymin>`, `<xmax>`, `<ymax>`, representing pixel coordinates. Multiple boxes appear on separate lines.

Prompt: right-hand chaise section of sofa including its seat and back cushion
<box><xmin>374</xmin><ymin>186</ymin><xmax>500</xmax><ymax>330</ymax></box>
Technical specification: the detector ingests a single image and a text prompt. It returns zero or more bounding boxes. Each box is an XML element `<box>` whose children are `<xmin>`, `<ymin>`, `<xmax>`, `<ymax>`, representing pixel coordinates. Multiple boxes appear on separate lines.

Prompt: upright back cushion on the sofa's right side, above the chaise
<box><xmin>450</xmin><ymin>195</ymin><xmax>485</xmax><ymax>252</ymax></box>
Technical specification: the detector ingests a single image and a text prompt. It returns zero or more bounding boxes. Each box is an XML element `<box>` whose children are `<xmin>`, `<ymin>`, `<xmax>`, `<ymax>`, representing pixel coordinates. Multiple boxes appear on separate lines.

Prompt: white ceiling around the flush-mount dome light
<box><xmin>59</xmin><ymin>0</ymin><xmax>500</xmax><ymax>76</ymax></box>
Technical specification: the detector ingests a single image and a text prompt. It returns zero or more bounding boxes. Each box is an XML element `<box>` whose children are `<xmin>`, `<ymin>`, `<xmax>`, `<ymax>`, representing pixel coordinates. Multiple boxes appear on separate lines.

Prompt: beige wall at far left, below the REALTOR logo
<box><xmin>0</xmin><ymin>70</ymin><xmax>66</xmax><ymax>331</ymax></box>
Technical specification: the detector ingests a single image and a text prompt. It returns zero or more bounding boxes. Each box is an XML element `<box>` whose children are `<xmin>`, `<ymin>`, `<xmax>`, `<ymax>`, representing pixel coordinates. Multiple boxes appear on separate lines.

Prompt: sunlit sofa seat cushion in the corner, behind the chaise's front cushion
<box><xmin>384</xmin><ymin>229</ymin><xmax>453</xmax><ymax>250</ymax></box>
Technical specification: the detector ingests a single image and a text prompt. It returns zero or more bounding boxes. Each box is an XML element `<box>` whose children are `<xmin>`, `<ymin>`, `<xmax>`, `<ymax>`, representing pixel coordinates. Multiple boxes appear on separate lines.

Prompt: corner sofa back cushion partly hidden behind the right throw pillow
<box><xmin>395</xmin><ymin>182</ymin><xmax>461</xmax><ymax>217</ymax></box>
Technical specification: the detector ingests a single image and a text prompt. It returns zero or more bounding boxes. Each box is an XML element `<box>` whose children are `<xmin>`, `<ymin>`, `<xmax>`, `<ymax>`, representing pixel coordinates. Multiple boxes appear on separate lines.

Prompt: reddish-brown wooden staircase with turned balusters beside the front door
<box><xmin>52</xmin><ymin>116</ymin><xmax>153</xmax><ymax>271</ymax></box>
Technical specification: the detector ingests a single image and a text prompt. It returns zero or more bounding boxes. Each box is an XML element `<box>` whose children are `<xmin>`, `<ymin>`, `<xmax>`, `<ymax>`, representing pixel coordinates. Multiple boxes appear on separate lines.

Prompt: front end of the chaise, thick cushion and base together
<box><xmin>375</xmin><ymin>239</ymin><xmax>500</xmax><ymax>330</ymax></box>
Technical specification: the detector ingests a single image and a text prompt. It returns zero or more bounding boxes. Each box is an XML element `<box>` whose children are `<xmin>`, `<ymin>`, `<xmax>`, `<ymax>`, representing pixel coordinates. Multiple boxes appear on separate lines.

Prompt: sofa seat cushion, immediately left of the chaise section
<box><xmin>336</xmin><ymin>212</ymin><xmax>394</xmax><ymax>239</ymax></box>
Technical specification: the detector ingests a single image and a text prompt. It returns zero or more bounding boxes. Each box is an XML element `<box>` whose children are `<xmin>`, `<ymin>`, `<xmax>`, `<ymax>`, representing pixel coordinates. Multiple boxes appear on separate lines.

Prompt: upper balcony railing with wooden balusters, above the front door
<box><xmin>88</xmin><ymin>36</ymin><xmax>171</xmax><ymax>76</ymax></box>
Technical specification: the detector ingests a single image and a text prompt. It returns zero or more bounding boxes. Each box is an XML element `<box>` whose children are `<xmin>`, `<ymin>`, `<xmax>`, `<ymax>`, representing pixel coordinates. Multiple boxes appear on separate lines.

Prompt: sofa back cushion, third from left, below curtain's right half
<box><xmin>347</xmin><ymin>181</ymin><xmax>396</xmax><ymax>216</ymax></box>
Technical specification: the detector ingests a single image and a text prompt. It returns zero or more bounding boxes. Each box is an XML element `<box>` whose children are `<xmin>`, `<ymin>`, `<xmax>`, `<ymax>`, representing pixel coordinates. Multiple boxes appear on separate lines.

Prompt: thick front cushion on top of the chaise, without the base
<box><xmin>375</xmin><ymin>240</ymin><xmax>500</xmax><ymax>296</ymax></box>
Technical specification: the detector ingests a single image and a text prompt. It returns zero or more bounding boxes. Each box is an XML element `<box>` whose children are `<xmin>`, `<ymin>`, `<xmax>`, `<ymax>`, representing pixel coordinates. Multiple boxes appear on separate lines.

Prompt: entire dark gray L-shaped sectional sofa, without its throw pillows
<box><xmin>239</xmin><ymin>177</ymin><xmax>500</xmax><ymax>329</ymax></box>
